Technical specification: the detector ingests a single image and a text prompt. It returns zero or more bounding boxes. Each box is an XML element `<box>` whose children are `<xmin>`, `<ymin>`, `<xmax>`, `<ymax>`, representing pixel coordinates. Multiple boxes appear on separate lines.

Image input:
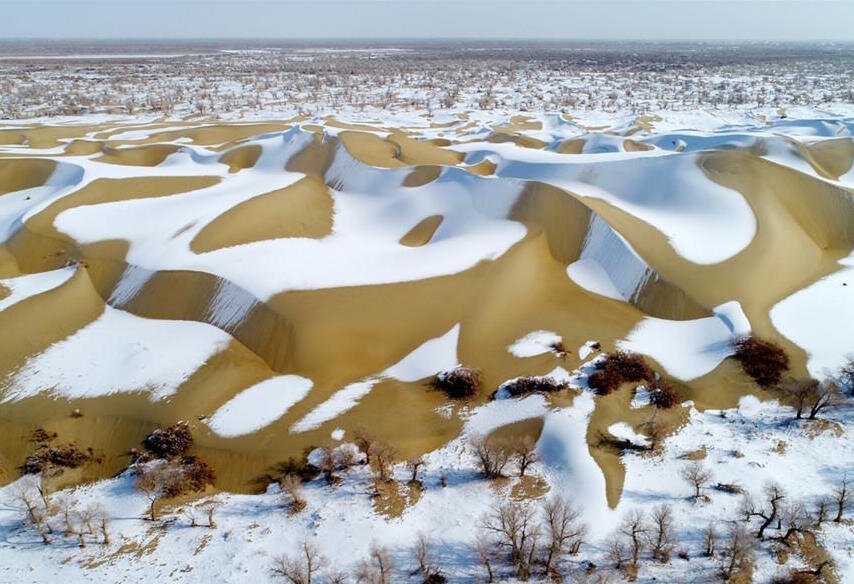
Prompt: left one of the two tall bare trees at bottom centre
<box><xmin>482</xmin><ymin>501</ymin><xmax>540</xmax><ymax>580</ymax></box>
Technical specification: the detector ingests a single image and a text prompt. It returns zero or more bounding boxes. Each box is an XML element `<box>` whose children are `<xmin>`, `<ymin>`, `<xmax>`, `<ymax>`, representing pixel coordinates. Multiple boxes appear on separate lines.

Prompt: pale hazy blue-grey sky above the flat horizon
<box><xmin>0</xmin><ymin>0</ymin><xmax>854</xmax><ymax>41</ymax></box>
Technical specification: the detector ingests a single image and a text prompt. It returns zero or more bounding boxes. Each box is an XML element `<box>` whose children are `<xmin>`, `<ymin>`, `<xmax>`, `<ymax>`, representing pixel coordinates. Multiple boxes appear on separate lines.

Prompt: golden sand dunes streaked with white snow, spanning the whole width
<box><xmin>0</xmin><ymin>116</ymin><xmax>854</xmax><ymax>506</ymax></box>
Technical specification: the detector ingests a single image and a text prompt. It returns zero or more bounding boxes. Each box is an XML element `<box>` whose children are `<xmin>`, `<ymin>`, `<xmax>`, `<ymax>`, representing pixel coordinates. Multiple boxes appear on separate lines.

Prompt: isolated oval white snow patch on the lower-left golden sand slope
<box><xmin>206</xmin><ymin>375</ymin><xmax>313</xmax><ymax>437</ymax></box>
